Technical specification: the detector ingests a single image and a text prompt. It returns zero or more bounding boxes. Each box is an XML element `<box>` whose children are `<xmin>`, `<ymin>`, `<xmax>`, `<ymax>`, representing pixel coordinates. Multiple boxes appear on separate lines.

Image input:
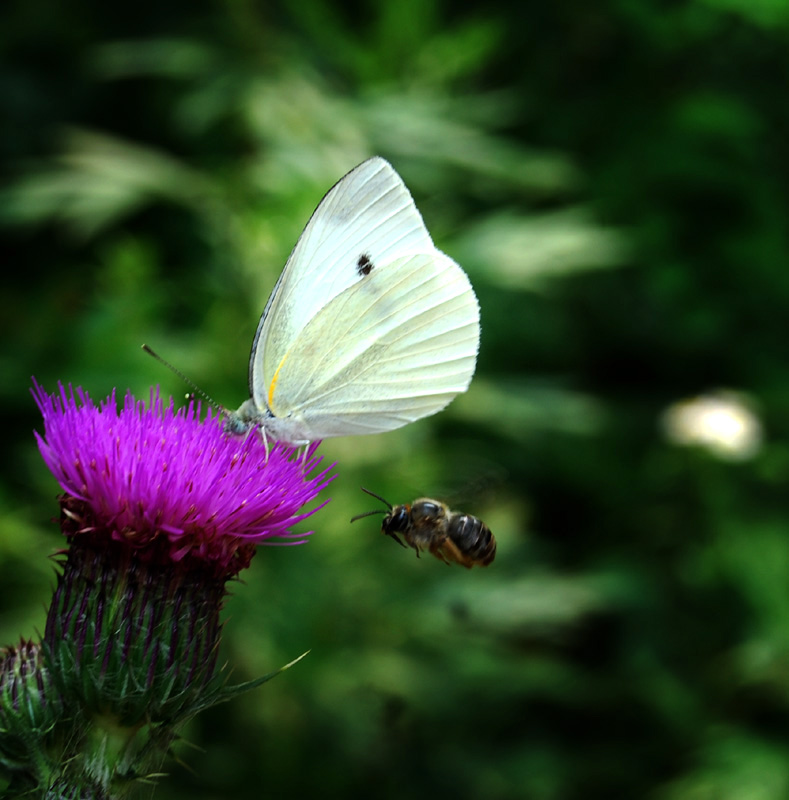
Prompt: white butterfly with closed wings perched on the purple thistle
<box><xmin>226</xmin><ymin>158</ymin><xmax>479</xmax><ymax>445</ymax></box>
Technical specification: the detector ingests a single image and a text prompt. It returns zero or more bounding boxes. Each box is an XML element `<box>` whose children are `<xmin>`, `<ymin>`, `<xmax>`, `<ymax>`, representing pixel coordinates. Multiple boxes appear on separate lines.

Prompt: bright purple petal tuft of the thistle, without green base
<box><xmin>31</xmin><ymin>380</ymin><xmax>333</xmax><ymax>577</ymax></box>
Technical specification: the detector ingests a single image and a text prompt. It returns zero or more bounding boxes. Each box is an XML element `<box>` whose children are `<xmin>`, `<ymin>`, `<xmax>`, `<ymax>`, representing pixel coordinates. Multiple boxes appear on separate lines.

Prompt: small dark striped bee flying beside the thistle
<box><xmin>351</xmin><ymin>487</ymin><xmax>496</xmax><ymax>569</ymax></box>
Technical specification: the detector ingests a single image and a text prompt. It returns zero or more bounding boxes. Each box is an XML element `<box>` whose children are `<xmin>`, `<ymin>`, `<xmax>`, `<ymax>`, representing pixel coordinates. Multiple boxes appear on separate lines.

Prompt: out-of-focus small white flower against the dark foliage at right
<box><xmin>662</xmin><ymin>390</ymin><xmax>762</xmax><ymax>461</ymax></box>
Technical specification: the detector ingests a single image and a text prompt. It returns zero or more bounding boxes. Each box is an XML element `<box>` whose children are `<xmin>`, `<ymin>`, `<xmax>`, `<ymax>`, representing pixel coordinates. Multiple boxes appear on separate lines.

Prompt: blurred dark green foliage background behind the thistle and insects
<box><xmin>0</xmin><ymin>0</ymin><xmax>789</xmax><ymax>800</ymax></box>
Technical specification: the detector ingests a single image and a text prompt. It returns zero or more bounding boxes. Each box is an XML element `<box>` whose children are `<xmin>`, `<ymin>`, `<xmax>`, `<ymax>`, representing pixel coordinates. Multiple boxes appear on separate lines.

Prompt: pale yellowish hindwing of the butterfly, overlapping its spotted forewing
<box><xmin>264</xmin><ymin>251</ymin><xmax>479</xmax><ymax>438</ymax></box>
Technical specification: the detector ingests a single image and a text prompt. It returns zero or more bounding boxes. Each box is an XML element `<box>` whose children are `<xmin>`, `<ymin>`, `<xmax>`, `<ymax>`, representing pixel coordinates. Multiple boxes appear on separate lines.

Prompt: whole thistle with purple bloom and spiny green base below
<box><xmin>18</xmin><ymin>381</ymin><xmax>332</xmax><ymax>798</ymax></box>
